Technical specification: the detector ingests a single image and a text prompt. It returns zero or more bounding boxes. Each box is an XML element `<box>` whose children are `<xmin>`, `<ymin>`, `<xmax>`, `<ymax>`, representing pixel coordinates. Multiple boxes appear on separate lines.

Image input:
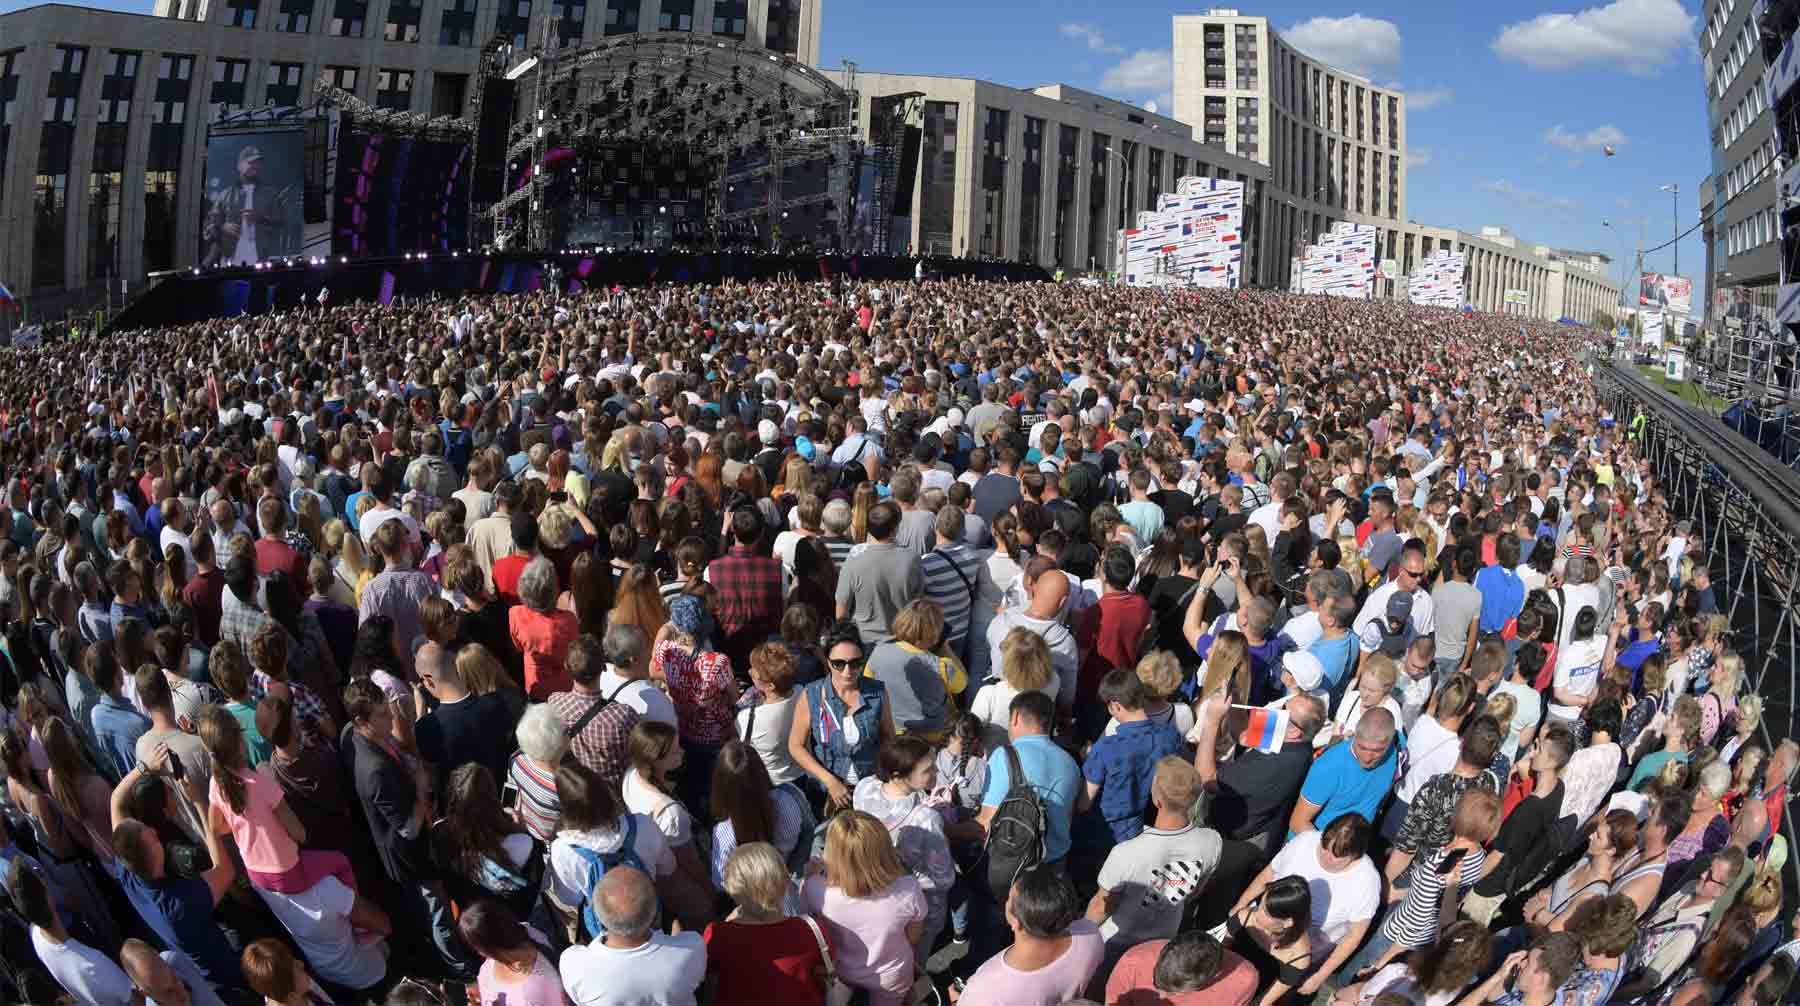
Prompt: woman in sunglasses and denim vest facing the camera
<box><xmin>788</xmin><ymin>621</ymin><xmax>895</xmax><ymax>810</ymax></box>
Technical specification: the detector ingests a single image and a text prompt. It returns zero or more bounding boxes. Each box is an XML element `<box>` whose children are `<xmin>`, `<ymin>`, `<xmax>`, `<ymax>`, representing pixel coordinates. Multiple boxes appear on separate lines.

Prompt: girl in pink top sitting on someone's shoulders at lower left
<box><xmin>200</xmin><ymin>705</ymin><xmax>356</xmax><ymax>894</ymax></box>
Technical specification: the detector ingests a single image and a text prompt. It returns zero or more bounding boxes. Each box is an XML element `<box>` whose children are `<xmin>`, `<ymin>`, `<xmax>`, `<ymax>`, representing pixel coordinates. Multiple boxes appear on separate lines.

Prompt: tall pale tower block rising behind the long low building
<box><xmin>1174</xmin><ymin>9</ymin><xmax>1431</xmax><ymax>295</ymax></box>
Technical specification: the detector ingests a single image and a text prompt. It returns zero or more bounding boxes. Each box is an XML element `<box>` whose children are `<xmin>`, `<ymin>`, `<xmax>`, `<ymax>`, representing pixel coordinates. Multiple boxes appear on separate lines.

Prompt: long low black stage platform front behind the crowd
<box><xmin>108</xmin><ymin>252</ymin><xmax>1049</xmax><ymax>331</ymax></box>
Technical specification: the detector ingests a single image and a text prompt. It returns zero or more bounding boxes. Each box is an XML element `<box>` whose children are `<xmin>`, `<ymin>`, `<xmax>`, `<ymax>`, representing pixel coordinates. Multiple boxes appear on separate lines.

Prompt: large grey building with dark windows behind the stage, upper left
<box><xmin>0</xmin><ymin>0</ymin><xmax>821</xmax><ymax>306</ymax></box>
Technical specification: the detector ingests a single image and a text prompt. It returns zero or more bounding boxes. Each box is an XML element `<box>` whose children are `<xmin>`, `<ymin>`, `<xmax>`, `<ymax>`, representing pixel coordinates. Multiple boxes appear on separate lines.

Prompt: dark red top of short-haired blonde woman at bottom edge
<box><xmin>706</xmin><ymin>918</ymin><xmax>832</xmax><ymax>1006</ymax></box>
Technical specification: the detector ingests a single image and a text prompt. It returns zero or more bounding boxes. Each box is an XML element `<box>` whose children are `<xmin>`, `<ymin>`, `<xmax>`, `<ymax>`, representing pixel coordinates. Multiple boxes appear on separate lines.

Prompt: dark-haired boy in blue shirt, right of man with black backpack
<box><xmin>1078</xmin><ymin>668</ymin><xmax>1184</xmax><ymax>842</ymax></box>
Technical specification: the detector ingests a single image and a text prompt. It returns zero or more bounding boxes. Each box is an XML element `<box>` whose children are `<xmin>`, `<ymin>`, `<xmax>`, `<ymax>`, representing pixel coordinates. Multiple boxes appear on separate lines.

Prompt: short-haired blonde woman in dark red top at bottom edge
<box><xmin>706</xmin><ymin>842</ymin><xmax>832</xmax><ymax>1006</ymax></box>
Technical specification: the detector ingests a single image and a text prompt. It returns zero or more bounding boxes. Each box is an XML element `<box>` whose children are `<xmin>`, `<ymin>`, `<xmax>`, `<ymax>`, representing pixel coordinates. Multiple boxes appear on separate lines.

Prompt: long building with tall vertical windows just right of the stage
<box><xmin>828</xmin><ymin>70</ymin><xmax>1285</xmax><ymax>284</ymax></box>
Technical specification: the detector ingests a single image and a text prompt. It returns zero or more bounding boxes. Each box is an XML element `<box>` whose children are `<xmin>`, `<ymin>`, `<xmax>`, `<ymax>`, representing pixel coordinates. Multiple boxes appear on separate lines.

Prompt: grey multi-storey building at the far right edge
<box><xmin>1681</xmin><ymin>0</ymin><xmax>1782</xmax><ymax>317</ymax></box>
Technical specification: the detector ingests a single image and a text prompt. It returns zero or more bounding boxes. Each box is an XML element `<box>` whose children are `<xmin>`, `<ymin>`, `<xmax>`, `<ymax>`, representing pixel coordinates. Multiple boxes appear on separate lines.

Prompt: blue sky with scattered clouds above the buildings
<box><xmin>819</xmin><ymin>0</ymin><xmax>1713</xmax><ymax>291</ymax></box>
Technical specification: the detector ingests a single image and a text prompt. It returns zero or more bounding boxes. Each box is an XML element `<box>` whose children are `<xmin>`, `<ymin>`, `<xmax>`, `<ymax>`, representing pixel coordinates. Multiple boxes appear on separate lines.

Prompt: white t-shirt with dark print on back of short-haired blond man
<box><xmin>1100</xmin><ymin>824</ymin><xmax>1224</xmax><ymax>954</ymax></box>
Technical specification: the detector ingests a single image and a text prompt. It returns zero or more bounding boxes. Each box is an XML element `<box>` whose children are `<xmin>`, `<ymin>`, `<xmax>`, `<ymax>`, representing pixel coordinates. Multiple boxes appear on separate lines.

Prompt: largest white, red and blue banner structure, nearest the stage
<box><xmin>1118</xmin><ymin>178</ymin><xmax>1244</xmax><ymax>288</ymax></box>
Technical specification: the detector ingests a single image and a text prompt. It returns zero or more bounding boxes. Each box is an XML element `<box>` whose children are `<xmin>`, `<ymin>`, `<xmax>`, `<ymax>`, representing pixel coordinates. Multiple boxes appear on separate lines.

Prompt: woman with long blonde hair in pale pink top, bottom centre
<box><xmin>801</xmin><ymin>810</ymin><xmax>929</xmax><ymax>1006</ymax></box>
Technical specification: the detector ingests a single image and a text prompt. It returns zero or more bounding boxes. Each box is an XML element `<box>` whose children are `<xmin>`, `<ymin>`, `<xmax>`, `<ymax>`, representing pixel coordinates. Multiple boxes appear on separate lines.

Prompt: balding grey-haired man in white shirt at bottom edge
<box><xmin>558</xmin><ymin>866</ymin><xmax>706</xmax><ymax>1006</ymax></box>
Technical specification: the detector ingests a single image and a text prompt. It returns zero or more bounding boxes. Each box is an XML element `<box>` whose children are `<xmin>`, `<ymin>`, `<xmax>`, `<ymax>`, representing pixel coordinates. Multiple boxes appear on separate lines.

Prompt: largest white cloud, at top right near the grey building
<box><xmin>1492</xmin><ymin>0</ymin><xmax>1696</xmax><ymax>77</ymax></box>
